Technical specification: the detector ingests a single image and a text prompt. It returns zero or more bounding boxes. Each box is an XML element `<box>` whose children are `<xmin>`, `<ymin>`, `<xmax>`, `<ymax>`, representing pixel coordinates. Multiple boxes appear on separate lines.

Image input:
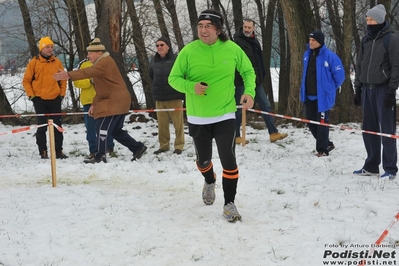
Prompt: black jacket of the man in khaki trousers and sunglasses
<box><xmin>148</xmin><ymin>49</ymin><xmax>184</xmax><ymax>101</ymax></box>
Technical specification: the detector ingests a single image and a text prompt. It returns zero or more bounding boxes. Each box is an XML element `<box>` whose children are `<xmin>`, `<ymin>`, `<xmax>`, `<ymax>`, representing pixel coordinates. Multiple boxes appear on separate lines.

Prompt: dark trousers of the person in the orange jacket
<box><xmin>33</xmin><ymin>97</ymin><xmax>64</xmax><ymax>154</ymax></box>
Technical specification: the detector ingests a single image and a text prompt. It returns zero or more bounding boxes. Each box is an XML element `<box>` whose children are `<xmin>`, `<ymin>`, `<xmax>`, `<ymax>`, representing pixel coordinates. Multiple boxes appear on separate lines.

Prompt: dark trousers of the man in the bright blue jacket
<box><xmin>305</xmin><ymin>100</ymin><xmax>333</xmax><ymax>154</ymax></box>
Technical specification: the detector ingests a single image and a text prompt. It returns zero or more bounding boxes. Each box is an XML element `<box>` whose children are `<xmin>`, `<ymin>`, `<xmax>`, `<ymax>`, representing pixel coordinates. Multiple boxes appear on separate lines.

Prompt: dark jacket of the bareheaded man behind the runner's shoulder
<box><xmin>234</xmin><ymin>27</ymin><xmax>266</xmax><ymax>85</ymax></box>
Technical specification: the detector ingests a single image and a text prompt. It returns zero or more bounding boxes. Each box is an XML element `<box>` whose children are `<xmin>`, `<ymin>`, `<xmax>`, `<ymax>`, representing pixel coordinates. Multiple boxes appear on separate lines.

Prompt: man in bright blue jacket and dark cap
<box><xmin>300</xmin><ymin>30</ymin><xmax>345</xmax><ymax>157</ymax></box>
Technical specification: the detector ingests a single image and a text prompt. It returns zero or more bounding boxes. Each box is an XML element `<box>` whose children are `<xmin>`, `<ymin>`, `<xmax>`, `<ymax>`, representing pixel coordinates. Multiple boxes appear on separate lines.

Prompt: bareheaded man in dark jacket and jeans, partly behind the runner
<box><xmin>234</xmin><ymin>19</ymin><xmax>287</xmax><ymax>144</ymax></box>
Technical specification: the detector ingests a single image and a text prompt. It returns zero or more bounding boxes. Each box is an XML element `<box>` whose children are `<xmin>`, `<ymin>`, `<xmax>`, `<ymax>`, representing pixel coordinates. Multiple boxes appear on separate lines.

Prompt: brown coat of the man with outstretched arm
<box><xmin>68</xmin><ymin>52</ymin><xmax>131</xmax><ymax>119</ymax></box>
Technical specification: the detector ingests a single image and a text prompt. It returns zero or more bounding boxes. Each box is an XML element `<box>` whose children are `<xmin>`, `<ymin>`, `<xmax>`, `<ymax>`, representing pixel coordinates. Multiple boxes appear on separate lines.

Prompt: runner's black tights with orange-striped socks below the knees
<box><xmin>189</xmin><ymin>119</ymin><xmax>238</xmax><ymax>204</ymax></box>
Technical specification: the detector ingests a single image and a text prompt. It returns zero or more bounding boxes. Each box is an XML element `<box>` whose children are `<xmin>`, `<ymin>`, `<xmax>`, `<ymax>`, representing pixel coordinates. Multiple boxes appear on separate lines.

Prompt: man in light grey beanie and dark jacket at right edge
<box><xmin>353</xmin><ymin>4</ymin><xmax>399</xmax><ymax>179</ymax></box>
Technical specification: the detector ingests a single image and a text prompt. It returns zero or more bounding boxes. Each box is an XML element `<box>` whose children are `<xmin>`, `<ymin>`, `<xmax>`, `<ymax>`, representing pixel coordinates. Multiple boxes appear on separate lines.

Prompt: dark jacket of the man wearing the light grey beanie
<box><xmin>355</xmin><ymin>22</ymin><xmax>399</xmax><ymax>94</ymax></box>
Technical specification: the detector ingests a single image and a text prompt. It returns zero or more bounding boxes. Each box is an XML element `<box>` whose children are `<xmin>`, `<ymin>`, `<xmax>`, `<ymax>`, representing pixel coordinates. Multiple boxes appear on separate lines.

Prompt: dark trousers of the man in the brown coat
<box><xmin>95</xmin><ymin>115</ymin><xmax>144</xmax><ymax>159</ymax></box>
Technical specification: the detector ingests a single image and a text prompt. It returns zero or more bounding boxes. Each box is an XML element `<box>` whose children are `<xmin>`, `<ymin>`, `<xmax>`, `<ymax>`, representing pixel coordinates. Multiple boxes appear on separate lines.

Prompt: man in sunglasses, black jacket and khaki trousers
<box><xmin>148</xmin><ymin>37</ymin><xmax>184</xmax><ymax>154</ymax></box>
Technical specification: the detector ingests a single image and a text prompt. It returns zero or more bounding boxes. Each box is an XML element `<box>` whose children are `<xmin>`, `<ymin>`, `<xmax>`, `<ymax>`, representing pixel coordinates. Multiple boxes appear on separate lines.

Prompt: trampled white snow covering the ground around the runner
<box><xmin>0</xmin><ymin>72</ymin><xmax>399</xmax><ymax>266</ymax></box>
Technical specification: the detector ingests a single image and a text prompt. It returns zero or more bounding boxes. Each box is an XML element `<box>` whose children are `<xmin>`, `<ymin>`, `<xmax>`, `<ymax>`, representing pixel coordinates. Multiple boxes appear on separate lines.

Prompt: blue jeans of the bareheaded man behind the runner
<box><xmin>235</xmin><ymin>85</ymin><xmax>278</xmax><ymax>137</ymax></box>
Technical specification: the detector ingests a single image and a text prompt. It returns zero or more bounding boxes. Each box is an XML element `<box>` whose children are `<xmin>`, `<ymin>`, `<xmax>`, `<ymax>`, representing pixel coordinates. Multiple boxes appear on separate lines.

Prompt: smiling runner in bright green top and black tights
<box><xmin>169</xmin><ymin>10</ymin><xmax>255</xmax><ymax>222</ymax></box>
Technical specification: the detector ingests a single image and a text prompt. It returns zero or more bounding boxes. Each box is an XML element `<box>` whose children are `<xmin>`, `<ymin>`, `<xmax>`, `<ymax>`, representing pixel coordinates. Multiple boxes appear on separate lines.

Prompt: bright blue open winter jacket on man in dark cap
<box><xmin>300</xmin><ymin>44</ymin><xmax>345</xmax><ymax>112</ymax></box>
